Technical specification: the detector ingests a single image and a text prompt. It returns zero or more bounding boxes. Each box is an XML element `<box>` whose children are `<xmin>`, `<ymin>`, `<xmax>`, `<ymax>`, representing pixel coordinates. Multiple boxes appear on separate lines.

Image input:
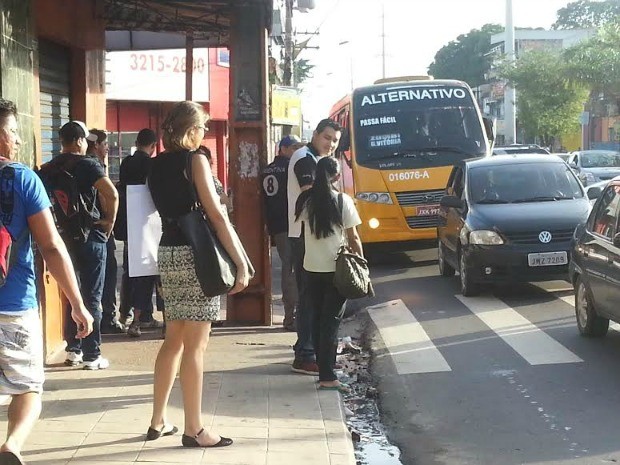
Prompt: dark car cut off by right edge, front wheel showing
<box><xmin>570</xmin><ymin>179</ymin><xmax>620</xmax><ymax>336</ymax></box>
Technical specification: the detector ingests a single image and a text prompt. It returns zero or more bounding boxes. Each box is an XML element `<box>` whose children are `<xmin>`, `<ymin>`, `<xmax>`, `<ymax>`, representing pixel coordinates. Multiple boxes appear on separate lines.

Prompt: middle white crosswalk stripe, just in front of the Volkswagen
<box><xmin>456</xmin><ymin>295</ymin><xmax>583</xmax><ymax>365</ymax></box>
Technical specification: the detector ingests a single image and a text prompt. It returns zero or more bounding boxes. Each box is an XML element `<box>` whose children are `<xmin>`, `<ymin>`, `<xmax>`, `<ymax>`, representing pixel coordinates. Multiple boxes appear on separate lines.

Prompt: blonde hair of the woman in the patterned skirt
<box><xmin>162</xmin><ymin>101</ymin><xmax>209</xmax><ymax>152</ymax></box>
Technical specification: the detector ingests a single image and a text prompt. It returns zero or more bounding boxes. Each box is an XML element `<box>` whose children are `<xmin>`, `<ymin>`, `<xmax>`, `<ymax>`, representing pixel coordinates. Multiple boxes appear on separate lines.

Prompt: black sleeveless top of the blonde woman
<box><xmin>148</xmin><ymin>151</ymin><xmax>207</xmax><ymax>246</ymax></box>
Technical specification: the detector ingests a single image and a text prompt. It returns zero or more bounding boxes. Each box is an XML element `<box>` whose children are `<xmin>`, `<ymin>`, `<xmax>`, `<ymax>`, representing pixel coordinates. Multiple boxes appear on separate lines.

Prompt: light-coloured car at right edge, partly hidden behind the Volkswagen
<box><xmin>568</xmin><ymin>150</ymin><xmax>620</xmax><ymax>186</ymax></box>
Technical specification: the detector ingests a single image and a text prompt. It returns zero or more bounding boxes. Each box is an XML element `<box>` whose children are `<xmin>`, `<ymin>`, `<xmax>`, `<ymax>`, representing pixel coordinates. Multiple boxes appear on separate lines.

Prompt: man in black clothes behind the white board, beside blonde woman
<box><xmin>115</xmin><ymin>129</ymin><xmax>163</xmax><ymax>337</ymax></box>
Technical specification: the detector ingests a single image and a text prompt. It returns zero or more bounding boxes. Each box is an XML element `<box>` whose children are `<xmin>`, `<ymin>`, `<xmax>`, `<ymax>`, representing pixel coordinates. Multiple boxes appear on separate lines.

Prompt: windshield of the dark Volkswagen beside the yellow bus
<box><xmin>468</xmin><ymin>162</ymin><xmax>584</xmax><ymax>204</ymax></box>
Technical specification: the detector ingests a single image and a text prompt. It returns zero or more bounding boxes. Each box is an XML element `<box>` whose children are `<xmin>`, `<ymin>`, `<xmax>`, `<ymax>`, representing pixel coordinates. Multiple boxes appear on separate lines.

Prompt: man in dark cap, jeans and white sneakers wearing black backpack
<box><xmin>49</xmin><ymin>121</ymin><xmax>118</xmax><ymax>370</ymax></box>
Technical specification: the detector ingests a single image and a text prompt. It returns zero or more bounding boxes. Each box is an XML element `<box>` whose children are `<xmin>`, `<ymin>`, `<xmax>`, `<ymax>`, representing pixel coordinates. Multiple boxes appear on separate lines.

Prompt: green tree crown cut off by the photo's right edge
<box><xmin>564</xmin><ymin>19</ymin><xmax>620</xmax><ymax>95</ymax></box>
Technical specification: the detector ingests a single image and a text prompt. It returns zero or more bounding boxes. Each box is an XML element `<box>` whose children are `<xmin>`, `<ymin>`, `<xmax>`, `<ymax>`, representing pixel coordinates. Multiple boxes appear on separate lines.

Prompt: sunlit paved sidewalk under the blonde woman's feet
<box><xmin>0</xmin><ymin>248</ymin><xmax>355</xmax><ymax>465</ymax></box>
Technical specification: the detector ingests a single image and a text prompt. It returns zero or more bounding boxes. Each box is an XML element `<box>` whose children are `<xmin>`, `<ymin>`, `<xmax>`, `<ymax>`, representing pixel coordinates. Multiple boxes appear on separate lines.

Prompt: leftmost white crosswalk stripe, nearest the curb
<box><xmin>368</xmin><ymin>299</ymin><xmax>451</xmax><ymax>375</ymax></box>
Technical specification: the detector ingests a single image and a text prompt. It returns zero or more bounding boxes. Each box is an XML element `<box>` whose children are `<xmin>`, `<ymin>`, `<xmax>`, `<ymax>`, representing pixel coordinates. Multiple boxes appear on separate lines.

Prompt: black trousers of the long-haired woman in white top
<box><xmin>304</xmin><ymin>270</ymin><xmax>346</xmax><ymax>381</ymax></box>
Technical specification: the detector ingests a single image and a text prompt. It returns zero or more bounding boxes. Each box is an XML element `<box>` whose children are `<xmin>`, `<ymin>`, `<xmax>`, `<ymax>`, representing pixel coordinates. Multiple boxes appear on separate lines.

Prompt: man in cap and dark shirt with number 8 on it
<box><xmin>262</xmin><ymin>135</ymin><xmax>303</xmax><ymax>331</ymax></box>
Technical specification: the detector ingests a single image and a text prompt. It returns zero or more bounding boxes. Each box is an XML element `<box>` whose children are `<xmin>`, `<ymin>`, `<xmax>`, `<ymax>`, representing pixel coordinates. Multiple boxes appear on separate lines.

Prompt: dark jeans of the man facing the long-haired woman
<box><xmin>289</xmin><ymin>237</ymin><xmax>315</xmax><ymax>362</ymax></box>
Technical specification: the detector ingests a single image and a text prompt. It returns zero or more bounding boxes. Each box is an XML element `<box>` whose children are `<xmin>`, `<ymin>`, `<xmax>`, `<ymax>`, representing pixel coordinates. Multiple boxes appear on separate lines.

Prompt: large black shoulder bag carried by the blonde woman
<box><xmin>177</xmin><ymin>153</ymin><xmax>255</xmax><ymax>297</ymax></box>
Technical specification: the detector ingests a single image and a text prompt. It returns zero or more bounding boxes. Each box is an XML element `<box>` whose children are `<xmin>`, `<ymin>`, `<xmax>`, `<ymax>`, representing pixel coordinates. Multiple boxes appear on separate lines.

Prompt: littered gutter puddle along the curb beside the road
<box><xmin>338</xmin><ymin>338</ymin><xmax>402</xmax><ymax>465</ymax></box>
